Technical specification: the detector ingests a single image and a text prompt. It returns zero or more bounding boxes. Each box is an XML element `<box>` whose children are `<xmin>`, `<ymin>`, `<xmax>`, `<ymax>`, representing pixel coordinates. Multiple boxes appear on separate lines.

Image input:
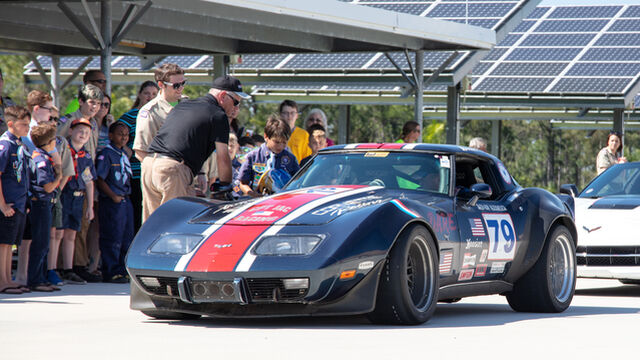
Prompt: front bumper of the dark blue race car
<box><xmin>129</xmin><ymin>261</ymin><xmax>384</xmax><ymax>317</ymax></box>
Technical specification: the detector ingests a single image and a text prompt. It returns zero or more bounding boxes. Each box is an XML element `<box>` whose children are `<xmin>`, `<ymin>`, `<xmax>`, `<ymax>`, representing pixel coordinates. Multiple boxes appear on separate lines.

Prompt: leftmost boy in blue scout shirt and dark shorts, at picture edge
<box><xmin>0</xmin><ymin>106</ymin><xmax>31</xmax><ymax>294</ymax></box>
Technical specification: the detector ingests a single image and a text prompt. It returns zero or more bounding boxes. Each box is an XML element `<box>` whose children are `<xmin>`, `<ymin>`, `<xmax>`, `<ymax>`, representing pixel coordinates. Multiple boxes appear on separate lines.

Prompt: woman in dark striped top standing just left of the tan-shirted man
<box><xmin>118</xmin><ymin>81</ymin><xmax>158</xmax><ymax>232</ymax></box>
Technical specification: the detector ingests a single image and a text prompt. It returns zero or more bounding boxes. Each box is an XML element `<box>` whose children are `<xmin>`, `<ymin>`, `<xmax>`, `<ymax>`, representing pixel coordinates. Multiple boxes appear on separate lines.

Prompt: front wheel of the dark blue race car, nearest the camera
<box><xmin>368</xmin><ymin>225</ymin><xmax>440</xmax><ymax>325</ymax></box>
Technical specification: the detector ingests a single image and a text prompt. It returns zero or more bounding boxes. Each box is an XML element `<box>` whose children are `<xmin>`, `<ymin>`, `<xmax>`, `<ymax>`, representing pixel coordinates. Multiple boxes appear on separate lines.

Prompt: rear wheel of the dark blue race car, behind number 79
<box><xmin>507</xmin><ymin>225</ymin><xmax>576</xmax><ymax>313</ymax></box>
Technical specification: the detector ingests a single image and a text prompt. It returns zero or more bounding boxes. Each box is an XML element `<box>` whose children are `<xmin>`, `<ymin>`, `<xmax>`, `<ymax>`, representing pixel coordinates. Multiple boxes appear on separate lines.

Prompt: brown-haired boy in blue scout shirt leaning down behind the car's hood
<box><xmin>238</xmin><ymin>116</ymin><xmax>300</xmax><ymax>197</ymax></box>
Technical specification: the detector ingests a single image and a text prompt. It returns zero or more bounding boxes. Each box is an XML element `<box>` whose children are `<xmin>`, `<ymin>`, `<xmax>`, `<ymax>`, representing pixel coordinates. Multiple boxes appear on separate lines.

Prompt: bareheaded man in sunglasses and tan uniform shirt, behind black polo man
<box><xmin>133</xmin><ymin>63</ymin><xmax>187</xmax><ymax>162</ymax></box>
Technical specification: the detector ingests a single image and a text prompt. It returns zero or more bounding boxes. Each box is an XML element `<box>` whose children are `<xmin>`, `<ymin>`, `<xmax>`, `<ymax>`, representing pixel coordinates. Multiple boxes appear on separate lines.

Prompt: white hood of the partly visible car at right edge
<box><xmin>575</xmin><ymin>196</ymin><xmax>640</xmax><ymax>246</ymax></box>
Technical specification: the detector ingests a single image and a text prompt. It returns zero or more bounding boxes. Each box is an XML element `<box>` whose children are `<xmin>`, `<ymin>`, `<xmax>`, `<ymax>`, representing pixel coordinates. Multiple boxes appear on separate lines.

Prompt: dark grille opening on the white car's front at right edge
<box><xmin>576</xmin><ymin>246</ymin><xmax>640</xmax><ymax>266</ymax></box>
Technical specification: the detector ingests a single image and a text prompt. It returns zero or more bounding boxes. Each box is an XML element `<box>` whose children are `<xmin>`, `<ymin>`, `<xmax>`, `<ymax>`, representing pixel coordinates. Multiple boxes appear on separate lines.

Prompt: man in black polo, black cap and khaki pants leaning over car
<box><xmin>142</xmin><ymin>75</ymin><xmax>249</xmax><ymax>221</ymax></box>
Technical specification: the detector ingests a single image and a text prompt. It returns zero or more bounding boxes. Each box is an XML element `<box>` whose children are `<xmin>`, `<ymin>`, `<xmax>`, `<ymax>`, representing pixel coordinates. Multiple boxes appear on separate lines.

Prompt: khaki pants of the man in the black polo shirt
<box><xmin>141</xmin><ymin>155</ymin><xmax>194</xmax><ymax>222</ymax></box>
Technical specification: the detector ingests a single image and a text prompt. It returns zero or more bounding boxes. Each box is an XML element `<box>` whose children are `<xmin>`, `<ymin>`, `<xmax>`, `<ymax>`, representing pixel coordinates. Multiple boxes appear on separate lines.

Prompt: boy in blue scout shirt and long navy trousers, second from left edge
<box><xmin>27</xmin><ymin>124</ymin><xmax>62</xmax><ymax>292</ymax></box>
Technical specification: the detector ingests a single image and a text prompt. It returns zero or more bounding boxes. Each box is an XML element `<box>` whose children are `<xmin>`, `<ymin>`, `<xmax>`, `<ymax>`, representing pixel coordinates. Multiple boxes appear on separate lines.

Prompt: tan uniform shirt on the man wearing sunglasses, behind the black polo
<box><xmin>133</xmin><ymin>94</ymin><xmax>173</xmax><ymax>151</ymax></box>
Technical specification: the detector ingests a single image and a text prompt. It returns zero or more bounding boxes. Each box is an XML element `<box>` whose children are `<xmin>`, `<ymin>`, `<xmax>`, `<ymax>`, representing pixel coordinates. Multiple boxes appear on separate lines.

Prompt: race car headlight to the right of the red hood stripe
<box><xmin>254</xmin><ymin>235</ymin><xmax>324</xmax><ymax>255</ymax></box>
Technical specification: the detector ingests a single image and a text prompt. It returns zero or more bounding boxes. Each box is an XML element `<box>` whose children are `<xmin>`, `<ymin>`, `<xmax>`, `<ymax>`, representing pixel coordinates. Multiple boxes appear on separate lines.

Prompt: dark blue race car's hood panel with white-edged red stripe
<box><xmin>190</xmin><ymin>185</ymin><xmax>392</xmax><ymax>226</ymax></box>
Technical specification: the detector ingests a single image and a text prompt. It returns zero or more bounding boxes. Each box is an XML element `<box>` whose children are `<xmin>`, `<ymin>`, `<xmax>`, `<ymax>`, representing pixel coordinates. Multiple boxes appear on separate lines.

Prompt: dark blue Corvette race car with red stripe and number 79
<box><xmin>126</xmin><ymin>144</ymin><xmax>576</xmax><ymax>324</ymax></box>
